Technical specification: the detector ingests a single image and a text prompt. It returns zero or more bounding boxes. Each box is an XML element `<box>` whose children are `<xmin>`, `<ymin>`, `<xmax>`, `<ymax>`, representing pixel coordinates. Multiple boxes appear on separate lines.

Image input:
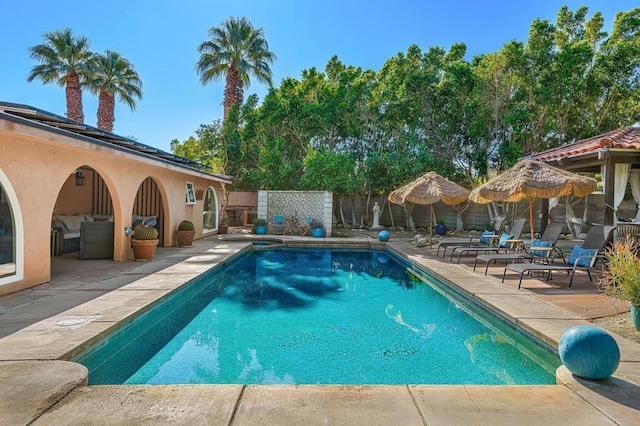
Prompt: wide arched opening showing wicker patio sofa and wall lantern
<box><xmin>51</xmin><ymin>165</ymin><xmax>114</xmax><ymax>259</ymax></box>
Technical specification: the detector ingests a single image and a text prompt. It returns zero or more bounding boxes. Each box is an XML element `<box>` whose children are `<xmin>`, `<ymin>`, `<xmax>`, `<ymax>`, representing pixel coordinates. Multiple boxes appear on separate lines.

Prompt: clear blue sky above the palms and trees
<box><xmin>0</xmin><ymin>0</ymin><xmax>638</xmax><ymax>151</ymax></box>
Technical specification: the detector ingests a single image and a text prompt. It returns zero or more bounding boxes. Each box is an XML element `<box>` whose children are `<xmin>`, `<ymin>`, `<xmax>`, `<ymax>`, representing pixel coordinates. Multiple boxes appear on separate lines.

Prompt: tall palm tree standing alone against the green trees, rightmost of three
<box><xmin>195</xmin><ymin>18</ymin><xmax>276</xmax><ymax>119</ymax></box>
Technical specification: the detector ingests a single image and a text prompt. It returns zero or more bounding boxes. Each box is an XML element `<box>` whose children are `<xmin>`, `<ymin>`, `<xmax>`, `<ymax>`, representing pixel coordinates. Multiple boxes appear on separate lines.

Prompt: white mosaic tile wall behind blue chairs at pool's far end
<box><xmin>258</xmin><ymin>191</ymin><xmax>333</xmax><ymax>236</ymax></box>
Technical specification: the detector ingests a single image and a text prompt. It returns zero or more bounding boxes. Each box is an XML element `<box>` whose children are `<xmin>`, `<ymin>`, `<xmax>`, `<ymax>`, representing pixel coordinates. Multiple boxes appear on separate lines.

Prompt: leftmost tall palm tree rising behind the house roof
<box><xmin>27</xmin><ymin>28</ymin><xmax>91</xmax><ymax>123</ymax></box>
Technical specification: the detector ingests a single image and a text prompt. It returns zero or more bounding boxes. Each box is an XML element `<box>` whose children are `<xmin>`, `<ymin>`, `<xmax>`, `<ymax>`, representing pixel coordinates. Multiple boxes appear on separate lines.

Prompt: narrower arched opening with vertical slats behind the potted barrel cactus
<box><xmin>131</xmin><ymin>177</ymin><xmax>164</xmax><ymax>243</ymax></box>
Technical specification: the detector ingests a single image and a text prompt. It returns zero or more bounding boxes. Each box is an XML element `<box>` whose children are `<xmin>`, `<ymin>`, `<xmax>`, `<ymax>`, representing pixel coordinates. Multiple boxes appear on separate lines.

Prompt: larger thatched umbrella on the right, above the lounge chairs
<box><xmin>469</xmin><ymin>160</ymin><xmax>598</xmax><ymax>238</ymax></box>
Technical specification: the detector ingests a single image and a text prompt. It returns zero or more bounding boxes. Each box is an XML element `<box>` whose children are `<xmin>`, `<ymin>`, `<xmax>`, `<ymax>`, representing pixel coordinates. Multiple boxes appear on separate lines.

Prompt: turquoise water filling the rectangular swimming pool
<box><xmin>77</xmin><ymin>248</ymin><xmax>560</xmax><ymax>384</ymax></box>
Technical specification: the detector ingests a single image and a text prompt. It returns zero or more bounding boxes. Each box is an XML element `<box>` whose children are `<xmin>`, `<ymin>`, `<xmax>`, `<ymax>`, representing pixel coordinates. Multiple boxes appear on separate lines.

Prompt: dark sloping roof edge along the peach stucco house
<box><xmin>0</xmin><ymin>102</ymin><xmax>233</xmax><ymax>183</ymax></box>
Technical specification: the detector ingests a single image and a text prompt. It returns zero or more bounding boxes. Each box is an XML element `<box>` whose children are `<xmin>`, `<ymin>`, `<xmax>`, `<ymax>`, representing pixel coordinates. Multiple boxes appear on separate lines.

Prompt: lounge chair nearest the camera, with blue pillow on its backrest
<box><xmin>502</xmin><ymin>225</ymin><xmax>616</xmax><ymax>288</ymax></box>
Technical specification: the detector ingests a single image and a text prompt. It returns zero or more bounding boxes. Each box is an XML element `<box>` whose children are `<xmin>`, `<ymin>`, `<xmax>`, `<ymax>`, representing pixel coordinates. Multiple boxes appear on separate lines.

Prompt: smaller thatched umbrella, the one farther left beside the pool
<box><xmin>389</xmin><ymin>172</ymin><xmax>469</xmax><ymax>243</ymax></box>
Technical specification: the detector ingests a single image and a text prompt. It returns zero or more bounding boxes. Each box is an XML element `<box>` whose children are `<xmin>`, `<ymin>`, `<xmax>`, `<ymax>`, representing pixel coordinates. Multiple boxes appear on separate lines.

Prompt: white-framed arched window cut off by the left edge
<box><xmin>0</xmin><ymin>171</ymin><xmax>24</xmax><ymax>285</ymax></box>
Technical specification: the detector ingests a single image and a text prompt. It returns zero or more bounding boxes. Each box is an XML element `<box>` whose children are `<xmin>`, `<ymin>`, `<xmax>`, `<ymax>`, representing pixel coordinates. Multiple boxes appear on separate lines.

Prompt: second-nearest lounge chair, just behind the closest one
<box><xmin>473</xmin><ymin>223</ymin><xmax>564</xmax><ymax>275</ymax></box>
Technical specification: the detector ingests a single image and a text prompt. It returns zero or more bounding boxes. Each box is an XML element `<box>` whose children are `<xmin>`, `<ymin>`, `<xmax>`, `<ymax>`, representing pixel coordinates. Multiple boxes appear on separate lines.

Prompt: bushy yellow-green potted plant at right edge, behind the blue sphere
<box><xmin>600</xmin><ymin>239</ymin><xmax>640</xmax><ymax>331</ymax></box>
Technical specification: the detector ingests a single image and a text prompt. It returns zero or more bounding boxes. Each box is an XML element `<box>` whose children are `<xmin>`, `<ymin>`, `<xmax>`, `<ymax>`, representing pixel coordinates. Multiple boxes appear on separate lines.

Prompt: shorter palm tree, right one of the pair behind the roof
<box><xmin>87</xmin><ymin>50</ymin><xmax>142</xmax><ymax>132</ymax></box>
